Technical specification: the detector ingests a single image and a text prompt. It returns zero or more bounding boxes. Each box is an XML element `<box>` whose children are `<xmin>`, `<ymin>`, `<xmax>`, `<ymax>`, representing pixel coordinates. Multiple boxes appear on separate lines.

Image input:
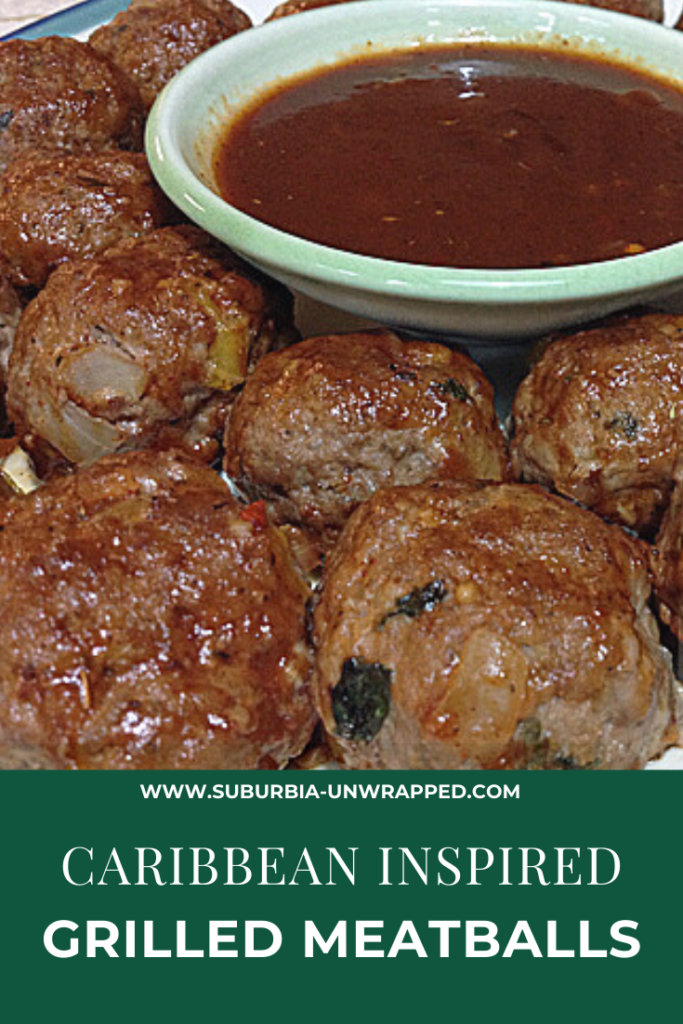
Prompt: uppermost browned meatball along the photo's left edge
<box><xmin>0</xmin><ymin>36</ymin><xmax>142</xmax><ymax>173</ymax></box>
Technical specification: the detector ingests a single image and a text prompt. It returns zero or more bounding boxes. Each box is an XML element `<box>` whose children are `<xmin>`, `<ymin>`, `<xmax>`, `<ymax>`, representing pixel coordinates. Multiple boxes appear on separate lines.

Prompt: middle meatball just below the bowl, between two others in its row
<box><xmin>225</xmin><ymin>331</ymin><xmax>508</xmax><ymax>534</ymax></box>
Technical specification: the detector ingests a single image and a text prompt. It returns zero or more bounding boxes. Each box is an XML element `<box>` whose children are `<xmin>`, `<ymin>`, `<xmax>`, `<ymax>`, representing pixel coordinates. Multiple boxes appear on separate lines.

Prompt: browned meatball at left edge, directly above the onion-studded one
<box><xmin>0</xmin><ymin>150</ymin><xmax>172</xmax><ymax>288</ymax></box>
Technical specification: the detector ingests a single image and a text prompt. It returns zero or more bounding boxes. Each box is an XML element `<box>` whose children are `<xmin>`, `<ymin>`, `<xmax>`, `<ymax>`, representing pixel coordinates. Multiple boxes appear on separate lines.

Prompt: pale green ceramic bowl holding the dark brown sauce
<box><xmin>147</xmin><ymin>0</ymin><xmax>683</xmax><ymax>341</ymax></box>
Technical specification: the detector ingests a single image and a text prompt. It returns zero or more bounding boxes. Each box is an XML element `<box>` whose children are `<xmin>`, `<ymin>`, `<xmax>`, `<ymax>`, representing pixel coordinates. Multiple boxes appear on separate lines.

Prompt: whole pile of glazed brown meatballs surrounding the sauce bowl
<box><xmin>0</xmin><ymin>0</ymin><xmax>683</xmax><ymax>769</ymax></box>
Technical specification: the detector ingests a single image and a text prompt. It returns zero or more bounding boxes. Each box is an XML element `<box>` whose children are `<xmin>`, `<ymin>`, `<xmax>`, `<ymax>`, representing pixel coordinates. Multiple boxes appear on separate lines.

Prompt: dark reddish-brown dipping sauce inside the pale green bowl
<box><xmin>215</xmin><ymin>44</ymin><xmax>683</xmax><ymax>268</ymax></box>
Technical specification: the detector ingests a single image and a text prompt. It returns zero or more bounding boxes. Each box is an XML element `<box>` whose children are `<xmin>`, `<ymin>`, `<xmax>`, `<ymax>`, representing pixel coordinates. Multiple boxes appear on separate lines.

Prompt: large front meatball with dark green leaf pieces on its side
<box><xmin>313</xmin><ymin>481</ymin><xmax>676</xmax><ymax>769</ymax></box>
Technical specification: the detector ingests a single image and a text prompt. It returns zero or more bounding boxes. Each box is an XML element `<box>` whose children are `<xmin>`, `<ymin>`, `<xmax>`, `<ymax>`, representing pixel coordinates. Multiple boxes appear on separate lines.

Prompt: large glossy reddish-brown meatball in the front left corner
<box><xmin>0</xmin><ymin>452</ymin><xmax>315</xmax><ymax>769</ymax></box>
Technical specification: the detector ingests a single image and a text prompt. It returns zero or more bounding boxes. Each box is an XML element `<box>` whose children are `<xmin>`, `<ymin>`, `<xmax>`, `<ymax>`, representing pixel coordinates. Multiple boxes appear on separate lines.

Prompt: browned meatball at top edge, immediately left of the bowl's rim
<box><xmin>90</xmin><ymin>0</ymin><xmax>252</xmax><ymax>110</ymax></box>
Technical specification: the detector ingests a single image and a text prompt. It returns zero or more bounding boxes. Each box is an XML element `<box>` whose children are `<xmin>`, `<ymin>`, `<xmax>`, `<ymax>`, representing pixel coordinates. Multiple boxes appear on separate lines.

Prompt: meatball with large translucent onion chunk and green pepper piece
<box><xmin>7</xmin><ymin>227</ymin><xmax>292</xmax><ymax>472</ymax></box>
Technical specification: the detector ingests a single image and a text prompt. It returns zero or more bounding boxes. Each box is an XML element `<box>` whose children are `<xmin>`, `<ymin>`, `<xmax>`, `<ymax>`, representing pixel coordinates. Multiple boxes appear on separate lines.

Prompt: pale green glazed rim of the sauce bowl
<box><xmin>145</xmin><ymin>0</ymin><xmax>683</xmax><ymax>305</ymax></box>
